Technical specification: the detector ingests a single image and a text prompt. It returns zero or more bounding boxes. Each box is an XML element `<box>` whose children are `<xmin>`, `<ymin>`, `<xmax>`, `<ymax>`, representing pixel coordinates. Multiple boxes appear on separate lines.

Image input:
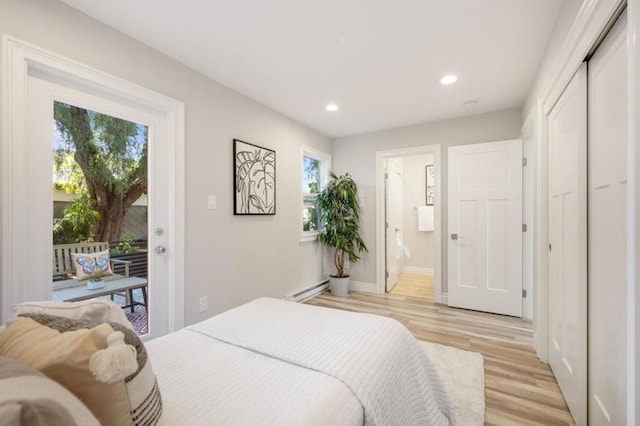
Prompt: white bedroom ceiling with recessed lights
<box><xmin>58</xmin><ymin>0</ymin><xmax>562</xmax><ymax>137</ymax></box>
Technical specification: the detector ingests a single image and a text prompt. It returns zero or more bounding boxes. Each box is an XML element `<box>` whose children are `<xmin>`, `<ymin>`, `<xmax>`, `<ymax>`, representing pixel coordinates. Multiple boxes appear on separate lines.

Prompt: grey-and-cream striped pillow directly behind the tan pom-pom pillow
<box><xmin>18</xmin><ymin>314</ymin><xmax>162</xmax><ymax>425</ymax></box>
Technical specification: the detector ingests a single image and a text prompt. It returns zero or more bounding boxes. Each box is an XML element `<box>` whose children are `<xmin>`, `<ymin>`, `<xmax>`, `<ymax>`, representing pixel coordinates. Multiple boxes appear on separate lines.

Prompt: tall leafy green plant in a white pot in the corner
<box><xmin>318</xmin><ymin>172</ymin><xmax>368</xmax><ymax>296</ymax></box>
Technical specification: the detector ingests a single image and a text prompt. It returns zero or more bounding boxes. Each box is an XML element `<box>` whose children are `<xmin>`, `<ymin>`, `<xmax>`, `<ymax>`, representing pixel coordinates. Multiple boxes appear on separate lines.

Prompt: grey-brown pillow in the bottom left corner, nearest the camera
<box><xmin>0</xmin><ymin>356</ymin><xmax>100</xmax><ymax>426</ymax></box>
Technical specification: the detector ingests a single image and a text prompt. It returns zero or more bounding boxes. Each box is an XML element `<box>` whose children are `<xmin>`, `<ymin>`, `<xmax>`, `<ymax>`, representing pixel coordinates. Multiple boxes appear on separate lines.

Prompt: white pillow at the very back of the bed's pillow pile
<box><xmin>11</xmin><ymin>299</ymin><xmax>133</xmax><ymax>330</ymax></box>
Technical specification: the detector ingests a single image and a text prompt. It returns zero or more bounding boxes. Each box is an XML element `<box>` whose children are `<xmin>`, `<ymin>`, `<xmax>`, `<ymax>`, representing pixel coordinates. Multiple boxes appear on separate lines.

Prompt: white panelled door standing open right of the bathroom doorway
<box><xmin>448</xmin><ymin>139</ymin><xmax>522</xmax><ymax>317</ymax></box>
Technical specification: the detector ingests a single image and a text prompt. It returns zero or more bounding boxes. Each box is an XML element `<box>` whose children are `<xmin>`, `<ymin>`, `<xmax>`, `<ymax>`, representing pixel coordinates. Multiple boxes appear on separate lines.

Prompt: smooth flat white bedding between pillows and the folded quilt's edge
<box><xmin>145</xmin><ymin>329</ymin><xmax>363</xmax><ymax>426</ymax></box>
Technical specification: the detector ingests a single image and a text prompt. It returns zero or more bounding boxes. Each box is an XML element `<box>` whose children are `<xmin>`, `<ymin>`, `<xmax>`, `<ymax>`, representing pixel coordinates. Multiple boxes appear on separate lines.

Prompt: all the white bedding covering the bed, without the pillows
<box><xmin>148</xmin><ymin>298</ymin><xmax>450</xmax><ymax>425</ymax></box>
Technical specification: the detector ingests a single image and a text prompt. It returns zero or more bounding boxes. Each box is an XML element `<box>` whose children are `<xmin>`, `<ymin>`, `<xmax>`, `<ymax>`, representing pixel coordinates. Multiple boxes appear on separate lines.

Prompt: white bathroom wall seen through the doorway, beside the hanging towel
<box><xmin>402</xmin><ymin>154</ymin><xmax>435</xmax><ymax>272</ymax></box>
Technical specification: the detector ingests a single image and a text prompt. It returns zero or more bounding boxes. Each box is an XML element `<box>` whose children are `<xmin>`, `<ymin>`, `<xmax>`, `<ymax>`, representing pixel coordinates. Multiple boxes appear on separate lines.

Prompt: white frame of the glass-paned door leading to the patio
<box><xmin>24</xmin><ymin>77</ymin><xmax>173</xmax><ymax>339</ymax></box>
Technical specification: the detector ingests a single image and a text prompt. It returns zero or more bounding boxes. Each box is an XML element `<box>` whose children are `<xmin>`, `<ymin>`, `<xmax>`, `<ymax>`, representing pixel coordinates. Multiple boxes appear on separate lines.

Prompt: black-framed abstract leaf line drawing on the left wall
<box><xmin>233</xmin><ymin>139</ymin><xmax>276</xmax><ymax>216</ymax></box>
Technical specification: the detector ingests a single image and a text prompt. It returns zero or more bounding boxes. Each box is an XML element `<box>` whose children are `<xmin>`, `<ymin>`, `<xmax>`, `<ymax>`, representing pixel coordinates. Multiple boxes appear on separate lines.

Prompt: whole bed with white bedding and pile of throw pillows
<box><xmin>0</xmin><ymin>298</ymin><xmax>456</xmax><ymax>426</ymax></box>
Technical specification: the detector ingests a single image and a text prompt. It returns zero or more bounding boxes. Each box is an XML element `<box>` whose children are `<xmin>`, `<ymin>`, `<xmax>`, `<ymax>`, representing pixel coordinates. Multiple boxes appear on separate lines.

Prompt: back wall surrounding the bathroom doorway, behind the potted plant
<box><xmin>332</xmin><ymin>108</ymin><xmax>522</xmax><ymax>292</ymax></box>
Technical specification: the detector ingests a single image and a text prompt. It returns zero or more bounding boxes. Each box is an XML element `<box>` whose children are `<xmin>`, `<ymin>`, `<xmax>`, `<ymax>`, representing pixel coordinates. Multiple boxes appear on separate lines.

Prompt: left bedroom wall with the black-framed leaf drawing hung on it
<box><xmin>0</xmin><ymin>0</ymin><xmax>331</xmax><ymax>324</ymax></box>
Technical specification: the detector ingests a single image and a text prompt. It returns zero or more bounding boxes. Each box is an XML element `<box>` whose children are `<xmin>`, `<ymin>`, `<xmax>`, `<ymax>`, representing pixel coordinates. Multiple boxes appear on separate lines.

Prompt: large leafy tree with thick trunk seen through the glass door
<box><xmin>54</xmin><ymin>102</ymin><xmax>148</xmax><ymax>241</ymax></box>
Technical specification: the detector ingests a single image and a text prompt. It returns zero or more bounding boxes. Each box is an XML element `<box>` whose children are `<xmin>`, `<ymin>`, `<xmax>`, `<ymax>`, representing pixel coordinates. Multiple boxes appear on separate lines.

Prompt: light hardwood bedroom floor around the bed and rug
<box><xmin>305</xmin><ymin>282</ymin><xmax>574</xmax><ymax>426</ymax></box>
